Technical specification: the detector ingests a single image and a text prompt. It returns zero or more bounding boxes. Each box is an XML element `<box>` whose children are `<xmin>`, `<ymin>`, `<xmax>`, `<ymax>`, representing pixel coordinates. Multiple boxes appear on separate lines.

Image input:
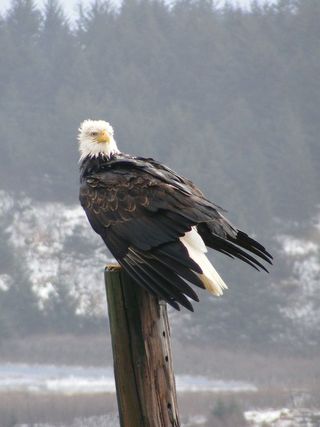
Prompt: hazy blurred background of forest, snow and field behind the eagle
<box><xmin>0</xmin><ymin>0</ymin><xmax>320</xmax><ymax>427</ymax></box>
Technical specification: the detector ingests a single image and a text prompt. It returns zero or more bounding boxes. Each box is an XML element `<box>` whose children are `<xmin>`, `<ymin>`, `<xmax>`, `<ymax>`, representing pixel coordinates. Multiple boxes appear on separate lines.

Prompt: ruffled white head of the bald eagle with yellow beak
<box><xmin>78</xmin><ymin>120</ymin><xmax>119</xmax><ymax>160</ymax></box>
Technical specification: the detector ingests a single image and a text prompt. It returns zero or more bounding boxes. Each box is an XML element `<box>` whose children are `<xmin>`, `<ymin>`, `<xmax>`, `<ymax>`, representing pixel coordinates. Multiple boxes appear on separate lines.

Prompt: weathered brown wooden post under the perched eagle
<box><xmin>105</xmin><ymin>267</ymin><xmax>180</xmax><ymax>427</ymax></box>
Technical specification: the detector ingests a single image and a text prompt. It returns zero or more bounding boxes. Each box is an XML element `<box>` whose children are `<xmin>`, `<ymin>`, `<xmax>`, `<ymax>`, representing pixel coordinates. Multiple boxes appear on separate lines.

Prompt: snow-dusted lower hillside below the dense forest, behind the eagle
<box><xmin>0</xmin><ymin>191</ymin><xmax>320</xmax><ymax>352</ymax></box>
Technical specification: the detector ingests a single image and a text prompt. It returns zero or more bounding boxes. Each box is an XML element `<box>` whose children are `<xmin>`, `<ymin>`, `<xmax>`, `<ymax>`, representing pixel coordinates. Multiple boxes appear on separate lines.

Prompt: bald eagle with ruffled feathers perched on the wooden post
<box><xmin>78</xmin><ymin>120</ymin><xmax>272</xmax><ymax>311</ymax></box>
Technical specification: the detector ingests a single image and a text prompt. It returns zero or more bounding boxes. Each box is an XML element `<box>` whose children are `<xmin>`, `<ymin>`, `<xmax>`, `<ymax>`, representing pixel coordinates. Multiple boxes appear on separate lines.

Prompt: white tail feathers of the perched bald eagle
<box><xmin>180</xmin><ymin>227</ymin><xmax>228</xmax><ymax>296</ymax></box>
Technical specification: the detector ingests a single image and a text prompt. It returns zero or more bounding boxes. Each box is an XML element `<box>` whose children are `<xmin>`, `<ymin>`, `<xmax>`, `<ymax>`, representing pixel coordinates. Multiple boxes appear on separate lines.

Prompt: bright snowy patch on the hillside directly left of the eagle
<box><xmin>0</xmin><ymin>192</ymin><xmax>111</xmax><ymax>315</ymax></box>
